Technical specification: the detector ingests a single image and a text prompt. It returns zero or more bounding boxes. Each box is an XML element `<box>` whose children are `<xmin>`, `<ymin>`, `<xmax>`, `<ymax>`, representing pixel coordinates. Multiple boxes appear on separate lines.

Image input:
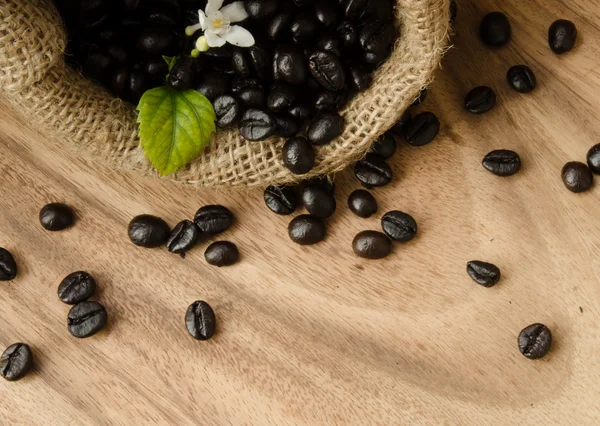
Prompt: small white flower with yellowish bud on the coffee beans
<box><xmin>185</xmin><ymin>0</ymin><xmax>254</xmax><ymax>52</ymax></box>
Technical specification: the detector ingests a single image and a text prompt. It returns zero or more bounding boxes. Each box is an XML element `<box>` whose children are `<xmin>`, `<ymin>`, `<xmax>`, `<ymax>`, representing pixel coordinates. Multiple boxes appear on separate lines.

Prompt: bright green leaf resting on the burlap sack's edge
<box><xmin>137</xmin><ymin>86</ymin><xmax>216</xmax><ymax>175</ymax></box>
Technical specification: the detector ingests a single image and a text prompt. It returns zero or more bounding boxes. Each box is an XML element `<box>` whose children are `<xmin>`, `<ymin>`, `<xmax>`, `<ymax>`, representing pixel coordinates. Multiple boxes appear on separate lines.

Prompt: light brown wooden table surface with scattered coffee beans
<box><xmin>0</xmin><ymin>0</ymin><xmax>600</xmax><ymax>425</ymax></box>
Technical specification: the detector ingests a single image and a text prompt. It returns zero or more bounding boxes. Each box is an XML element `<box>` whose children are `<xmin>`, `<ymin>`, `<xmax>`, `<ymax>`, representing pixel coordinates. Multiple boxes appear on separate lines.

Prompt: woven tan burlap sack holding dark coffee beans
<box><xmin>0</xmin><ymin>0</ymin><xmax>449</xmax><ymax>187</ymax></box>
